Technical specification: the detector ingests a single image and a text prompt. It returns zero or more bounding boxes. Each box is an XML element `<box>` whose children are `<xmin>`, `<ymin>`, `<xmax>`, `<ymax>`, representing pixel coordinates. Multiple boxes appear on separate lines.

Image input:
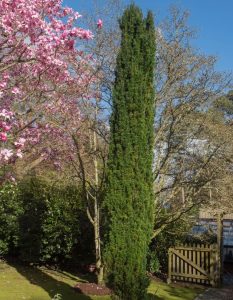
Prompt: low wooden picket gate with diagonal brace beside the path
<box><xmin>168</xmin><ymin>244</ymin><xmax>219</xmax><ymax>286</ymax></box>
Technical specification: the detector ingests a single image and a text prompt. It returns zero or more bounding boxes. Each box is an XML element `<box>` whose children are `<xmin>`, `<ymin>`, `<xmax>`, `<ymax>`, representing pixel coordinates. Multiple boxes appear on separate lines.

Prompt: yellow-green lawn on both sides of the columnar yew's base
<box><xmin>0</xmin><ymin>262</ymin><xmax>203</xmax><ymax>300</ymax></box>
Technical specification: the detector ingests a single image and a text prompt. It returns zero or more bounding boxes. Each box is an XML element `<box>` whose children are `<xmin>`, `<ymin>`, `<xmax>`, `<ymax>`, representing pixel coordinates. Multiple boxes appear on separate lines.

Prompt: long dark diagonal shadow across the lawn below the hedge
<box><xmin>8</xmin><ymin>262</ymin><xmax>91</xmax><ymax>300</ymax></box>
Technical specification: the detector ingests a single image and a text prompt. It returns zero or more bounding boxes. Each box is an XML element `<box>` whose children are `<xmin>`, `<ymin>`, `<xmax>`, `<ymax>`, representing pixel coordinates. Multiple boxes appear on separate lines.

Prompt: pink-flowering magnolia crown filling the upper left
<box><xmin>0</xmin><ymin>0</ymin><xmax>99</xmax><ymax>176</ymax></box>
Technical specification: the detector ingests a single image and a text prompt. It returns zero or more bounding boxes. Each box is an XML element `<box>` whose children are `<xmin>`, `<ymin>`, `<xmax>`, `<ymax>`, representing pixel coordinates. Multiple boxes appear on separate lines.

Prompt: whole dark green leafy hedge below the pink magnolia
<box><xmin>0</xmin><ymin>177</ymin><xmax>93</xmax><ymax>264</ymax></box>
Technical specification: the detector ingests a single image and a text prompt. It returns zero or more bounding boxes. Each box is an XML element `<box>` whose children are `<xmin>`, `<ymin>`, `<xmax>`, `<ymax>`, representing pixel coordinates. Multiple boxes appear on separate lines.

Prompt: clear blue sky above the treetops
<box><xmin>64</xmin><ymin>0</ymin><xmax>233</xmax><ymax>71</ymax></box>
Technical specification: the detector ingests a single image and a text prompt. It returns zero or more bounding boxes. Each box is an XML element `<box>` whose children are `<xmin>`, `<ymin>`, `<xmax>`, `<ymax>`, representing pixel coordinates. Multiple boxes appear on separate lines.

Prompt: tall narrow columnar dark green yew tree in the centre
<box><xmin>104</xmin><ymin>4</ymin><xmax>155</xmax><ymax>300</ymax></box>
